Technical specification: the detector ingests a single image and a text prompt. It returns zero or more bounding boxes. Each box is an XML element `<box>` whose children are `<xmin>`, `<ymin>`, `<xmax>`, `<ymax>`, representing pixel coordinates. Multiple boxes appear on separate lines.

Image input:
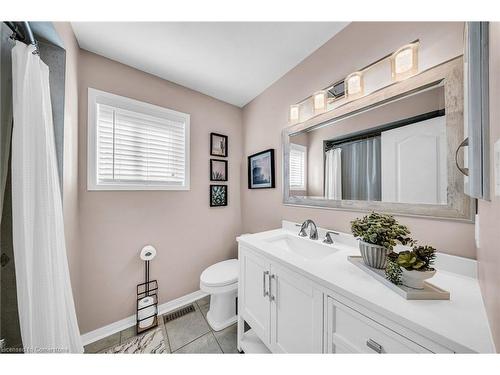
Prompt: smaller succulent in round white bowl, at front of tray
<box><xmin>385</xmin><ymin>246</ymin><xmax>436</xmax><ymax>289</ymax></box>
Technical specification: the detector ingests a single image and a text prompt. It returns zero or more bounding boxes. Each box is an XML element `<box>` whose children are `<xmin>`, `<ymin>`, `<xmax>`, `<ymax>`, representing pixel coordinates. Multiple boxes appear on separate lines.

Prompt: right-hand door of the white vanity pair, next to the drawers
<box><xmin>271</xmin><ymin>263</ymin><xmax>323</xmax><ymax>353</ymax></box>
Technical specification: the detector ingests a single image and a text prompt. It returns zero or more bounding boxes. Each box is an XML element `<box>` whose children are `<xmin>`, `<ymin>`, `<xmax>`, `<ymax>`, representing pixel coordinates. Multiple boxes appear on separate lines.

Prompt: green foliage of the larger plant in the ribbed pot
<box><xmin>351</xmin><ymin>212</ymin><xmax>415</xmax><ymax>251</ymax></box>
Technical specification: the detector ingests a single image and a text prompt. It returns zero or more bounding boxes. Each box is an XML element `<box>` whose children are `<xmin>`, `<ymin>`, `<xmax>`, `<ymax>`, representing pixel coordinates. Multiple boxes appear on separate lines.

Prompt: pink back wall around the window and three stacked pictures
<box><xmin>78</xmin><ymin>50</ymin><xmax>243</xmax><ymax>333</ymax></box>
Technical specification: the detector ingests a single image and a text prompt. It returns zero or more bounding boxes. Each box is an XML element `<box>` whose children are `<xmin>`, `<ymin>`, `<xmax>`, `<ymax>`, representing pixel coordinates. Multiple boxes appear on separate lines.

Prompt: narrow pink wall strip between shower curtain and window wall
<box><xmin>54</xmin><ymin>22</ymin><xmax>80</xmax><ymax>320</ymax></box>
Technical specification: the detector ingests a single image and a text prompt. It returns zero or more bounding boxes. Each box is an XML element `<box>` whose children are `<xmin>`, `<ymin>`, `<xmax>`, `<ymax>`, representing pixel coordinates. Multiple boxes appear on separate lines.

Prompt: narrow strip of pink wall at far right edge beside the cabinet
<box><xmin>477</xmin><ymin>22</ymin><xmax>500</xmax><ymax>352</ymax></box>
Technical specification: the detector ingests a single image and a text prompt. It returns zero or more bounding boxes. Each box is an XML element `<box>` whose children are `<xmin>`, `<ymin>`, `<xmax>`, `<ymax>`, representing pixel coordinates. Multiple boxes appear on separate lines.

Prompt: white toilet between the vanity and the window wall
<box><xmin>200</xmin><ymin>259</ymin><xmax>238</xmax><ymax>331</ymax></box>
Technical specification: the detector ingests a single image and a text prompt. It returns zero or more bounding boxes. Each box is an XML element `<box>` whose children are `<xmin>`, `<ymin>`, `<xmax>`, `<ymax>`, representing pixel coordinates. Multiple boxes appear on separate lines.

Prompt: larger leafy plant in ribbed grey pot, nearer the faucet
<box><xmin>351</xmin><ymin>212</ymin><xmax>414</xmax><ymax>269</ymax></box>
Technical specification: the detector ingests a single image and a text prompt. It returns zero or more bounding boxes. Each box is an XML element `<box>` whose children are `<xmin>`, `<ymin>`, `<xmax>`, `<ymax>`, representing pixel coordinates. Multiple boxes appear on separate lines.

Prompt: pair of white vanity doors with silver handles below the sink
<box><xmin>238</xmin><ymin>247</ymin><xmax>323</xmax><ymax>353</ymax></box>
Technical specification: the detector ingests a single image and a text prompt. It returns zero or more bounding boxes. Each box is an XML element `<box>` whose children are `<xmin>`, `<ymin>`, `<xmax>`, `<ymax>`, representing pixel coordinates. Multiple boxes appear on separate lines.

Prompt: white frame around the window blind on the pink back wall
<box><xmin>87</xmin><ymin>87</ymin><xmax>191</xmax><ymax>191</ymax></box>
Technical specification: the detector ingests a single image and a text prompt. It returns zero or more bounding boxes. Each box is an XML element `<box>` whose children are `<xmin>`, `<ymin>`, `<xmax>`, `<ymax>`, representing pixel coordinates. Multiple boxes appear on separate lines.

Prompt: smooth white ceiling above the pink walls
<box><xmin>72</xmin><ymin>22</ymin><xmax>348</xmax><ymax>107</ymax></box>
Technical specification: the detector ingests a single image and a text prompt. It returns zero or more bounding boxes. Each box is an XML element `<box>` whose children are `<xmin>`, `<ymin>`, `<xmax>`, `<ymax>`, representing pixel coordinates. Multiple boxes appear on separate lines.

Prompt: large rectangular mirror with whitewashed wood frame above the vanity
<box><xmin>283</xmin><ymin>57</ymin><xmax>475</xmax><ymax>221</ymax></box>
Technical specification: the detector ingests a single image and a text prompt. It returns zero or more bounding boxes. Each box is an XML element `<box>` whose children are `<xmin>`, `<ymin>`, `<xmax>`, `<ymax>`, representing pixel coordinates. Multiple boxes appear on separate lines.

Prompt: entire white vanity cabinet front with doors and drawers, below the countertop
<box><xmin>238</xmin><ymin>245</ymin><xmax>453</xmax><ymax>354</ymax></box>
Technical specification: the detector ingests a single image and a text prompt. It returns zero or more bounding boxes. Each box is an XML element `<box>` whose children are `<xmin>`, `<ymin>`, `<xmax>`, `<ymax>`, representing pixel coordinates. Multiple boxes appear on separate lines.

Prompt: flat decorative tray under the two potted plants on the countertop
<box><xmin>347</xmin><ymin>256</ymin><xmax>450</xmax><ymax>300</ymax></box>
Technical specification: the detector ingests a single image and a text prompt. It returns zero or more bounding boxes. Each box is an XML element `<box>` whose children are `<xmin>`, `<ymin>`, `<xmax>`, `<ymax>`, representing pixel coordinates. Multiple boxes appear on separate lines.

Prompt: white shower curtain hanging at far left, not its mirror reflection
<box><xmin>12</xmin><ymin>42</ymin><xmax>83</xmax><ymax>353</ymax></box>
